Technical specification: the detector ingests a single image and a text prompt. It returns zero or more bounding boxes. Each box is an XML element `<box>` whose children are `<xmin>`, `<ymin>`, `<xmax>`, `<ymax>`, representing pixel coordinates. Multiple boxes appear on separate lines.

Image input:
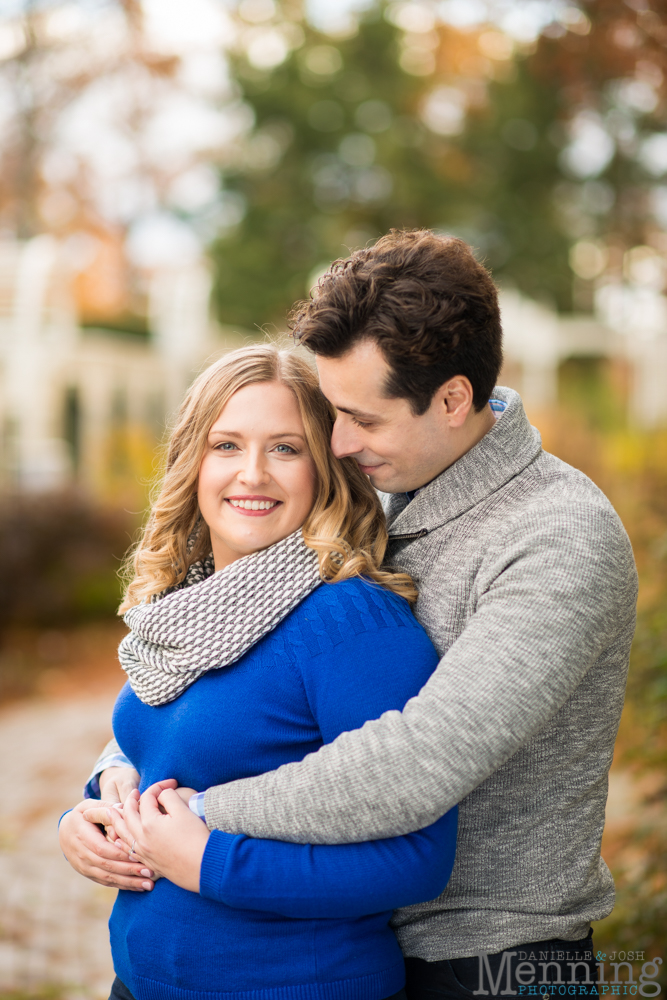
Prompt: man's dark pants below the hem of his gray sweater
<box><xmin>405</xmin><ymin>931</ymin><xmax>598</xmax><ymax>1000</ymax></box>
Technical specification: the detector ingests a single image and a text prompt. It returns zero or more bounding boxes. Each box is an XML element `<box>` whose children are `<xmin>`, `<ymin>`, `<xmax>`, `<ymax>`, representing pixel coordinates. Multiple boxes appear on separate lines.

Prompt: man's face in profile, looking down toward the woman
<box><xmin>316</xmin><ymin>340</ymin><xmax>459</xmax><ymax>493</ymax></box>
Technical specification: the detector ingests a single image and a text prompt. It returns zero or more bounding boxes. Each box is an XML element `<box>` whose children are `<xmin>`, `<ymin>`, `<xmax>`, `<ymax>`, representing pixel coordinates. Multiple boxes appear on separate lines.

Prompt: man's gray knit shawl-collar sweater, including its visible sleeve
<box><xmin>205</xmin><ymin>389</ymin><xmax>637</xmax><ymax>961</ymax></box>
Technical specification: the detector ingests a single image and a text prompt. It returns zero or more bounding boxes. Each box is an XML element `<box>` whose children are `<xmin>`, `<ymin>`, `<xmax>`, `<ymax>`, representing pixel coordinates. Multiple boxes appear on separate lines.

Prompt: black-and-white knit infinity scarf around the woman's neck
<box><xmin>118</xmin><ymin>528</ymin><xmax>322</xmax><ymax>706</ymax></box>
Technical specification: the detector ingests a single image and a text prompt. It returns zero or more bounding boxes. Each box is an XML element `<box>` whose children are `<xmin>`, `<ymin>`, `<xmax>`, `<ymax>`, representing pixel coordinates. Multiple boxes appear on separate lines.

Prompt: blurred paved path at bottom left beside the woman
<box><xmin>0</xmin><ymin>689</ymin><xmax>115</xmax><ymax>1000</ymax></box>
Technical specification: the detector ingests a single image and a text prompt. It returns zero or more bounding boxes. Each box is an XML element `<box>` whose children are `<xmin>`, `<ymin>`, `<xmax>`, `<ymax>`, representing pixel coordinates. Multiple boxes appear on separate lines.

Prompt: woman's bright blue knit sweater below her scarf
<box><xmin>110</xmin><ymin>579</ymin><xmax>457</xmax><ymax>1000</ymax></box>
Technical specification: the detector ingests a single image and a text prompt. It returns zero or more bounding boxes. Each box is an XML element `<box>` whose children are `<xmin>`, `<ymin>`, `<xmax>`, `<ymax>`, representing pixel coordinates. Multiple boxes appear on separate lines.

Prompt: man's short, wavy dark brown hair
<box><xmin>290</xmin><ymin>229</ymin><xmax>502</xmax><ymax>415</ymax></box>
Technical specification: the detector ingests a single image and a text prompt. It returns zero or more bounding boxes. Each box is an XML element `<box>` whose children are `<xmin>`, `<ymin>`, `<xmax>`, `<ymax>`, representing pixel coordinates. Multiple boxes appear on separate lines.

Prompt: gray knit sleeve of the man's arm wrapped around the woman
<box><xmin>205</xmin><ymin>506</ymin><xmax>636</xmax><ymax>844</ymax></box>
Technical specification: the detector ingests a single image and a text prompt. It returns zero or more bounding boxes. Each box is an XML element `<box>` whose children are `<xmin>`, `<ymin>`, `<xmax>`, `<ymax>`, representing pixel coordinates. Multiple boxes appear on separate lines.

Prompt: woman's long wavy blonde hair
<box><xmin>119</xmin><ymin>344</ymin><xmax>417</xmax><ymax>614</ymax></box>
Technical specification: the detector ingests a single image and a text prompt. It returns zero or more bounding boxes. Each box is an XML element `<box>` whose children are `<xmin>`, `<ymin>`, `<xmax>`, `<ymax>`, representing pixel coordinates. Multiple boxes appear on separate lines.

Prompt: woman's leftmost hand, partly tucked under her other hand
<box><xmin>58</xmin><ymin>799</ymin><xmax>157</xmax><ymax>892</ymax></box>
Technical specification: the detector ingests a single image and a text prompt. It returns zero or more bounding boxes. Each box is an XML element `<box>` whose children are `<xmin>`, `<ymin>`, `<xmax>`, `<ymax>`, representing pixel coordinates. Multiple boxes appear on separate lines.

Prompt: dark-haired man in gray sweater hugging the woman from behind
<box><xmin>62</xmin><ymin>232</ymin><xmax>636</xmax><ymax>1000</ymax></box>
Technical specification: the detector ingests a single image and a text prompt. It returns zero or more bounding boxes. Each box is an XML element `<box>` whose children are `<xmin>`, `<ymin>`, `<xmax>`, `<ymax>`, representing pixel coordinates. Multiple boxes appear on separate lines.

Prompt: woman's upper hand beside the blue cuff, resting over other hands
<box><xmin>110</xmin><ymin>782</ymin><xmax>210</xmax><ymax>892</ymax></box>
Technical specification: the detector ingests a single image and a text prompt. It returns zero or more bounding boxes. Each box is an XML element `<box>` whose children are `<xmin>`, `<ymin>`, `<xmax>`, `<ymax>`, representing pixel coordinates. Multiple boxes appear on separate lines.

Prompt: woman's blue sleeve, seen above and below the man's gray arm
<box><xmin>200</xmin><ymin>608</ymin><xmax>458</xmax><ymax>917</ymax></box>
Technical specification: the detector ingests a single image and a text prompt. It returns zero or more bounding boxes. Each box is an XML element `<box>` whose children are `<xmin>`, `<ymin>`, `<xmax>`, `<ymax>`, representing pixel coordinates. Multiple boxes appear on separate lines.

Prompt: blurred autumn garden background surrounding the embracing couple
<box><xmin>0</xmin><ymin>0</ymin><xmax>667</xmax><ymax>1000</ymax></box>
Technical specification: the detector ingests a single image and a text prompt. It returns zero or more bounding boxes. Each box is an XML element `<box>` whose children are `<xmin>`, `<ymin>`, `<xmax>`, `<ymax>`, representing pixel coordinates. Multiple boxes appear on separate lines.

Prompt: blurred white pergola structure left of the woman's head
<box><xmin>0</xmin><ymin>236</ymin><xmax>244</xmax><ymax>494</ymax></box>
